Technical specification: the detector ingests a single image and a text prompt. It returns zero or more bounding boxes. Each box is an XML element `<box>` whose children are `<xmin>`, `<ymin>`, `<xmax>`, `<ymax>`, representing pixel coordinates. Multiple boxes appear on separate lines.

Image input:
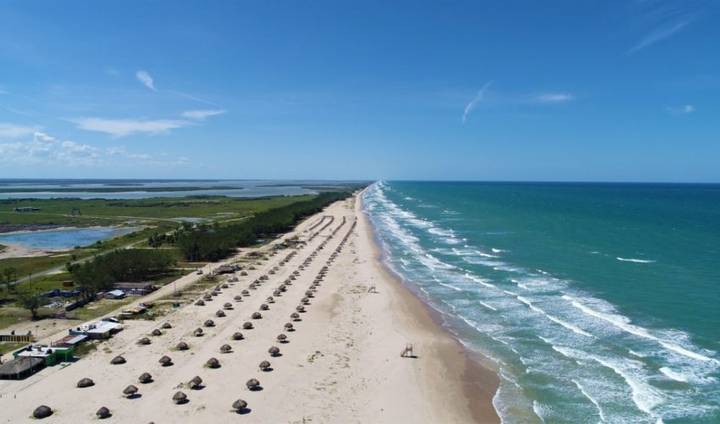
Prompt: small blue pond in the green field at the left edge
<box><xmin>0</xmin><ymin>227</ymin><xmax>137</xmax><ymax>249</ymax></box>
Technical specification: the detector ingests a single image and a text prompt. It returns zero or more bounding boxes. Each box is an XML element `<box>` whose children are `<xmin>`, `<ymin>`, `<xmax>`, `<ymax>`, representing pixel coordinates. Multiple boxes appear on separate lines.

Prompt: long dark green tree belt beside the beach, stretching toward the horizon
<box><xmin>176</xmin><ymin>192</ymin><xmax>350</xmax><ymax>261</ymax></box>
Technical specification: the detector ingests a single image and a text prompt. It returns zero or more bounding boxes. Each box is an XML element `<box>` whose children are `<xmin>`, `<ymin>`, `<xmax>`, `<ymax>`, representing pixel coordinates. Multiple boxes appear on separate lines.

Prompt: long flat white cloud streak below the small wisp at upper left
<box><xmin>69</xmin><ymin>117</ymin><xmax>193</xmax><ymax>137</ymax></box>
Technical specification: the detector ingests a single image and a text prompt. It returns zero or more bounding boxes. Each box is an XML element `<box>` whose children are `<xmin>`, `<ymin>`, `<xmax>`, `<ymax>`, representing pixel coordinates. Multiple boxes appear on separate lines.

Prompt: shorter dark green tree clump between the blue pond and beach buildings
<box><xmin>68</xmin><ymin>249</ymin><xmax>175</xmax><ymax>299</ymax></box>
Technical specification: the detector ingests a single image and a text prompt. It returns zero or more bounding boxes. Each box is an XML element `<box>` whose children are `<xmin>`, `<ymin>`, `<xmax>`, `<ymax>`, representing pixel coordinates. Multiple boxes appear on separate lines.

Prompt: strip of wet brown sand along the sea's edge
<box><xmin>357</xmin><ymin>190</ymin><xmax>501</xmax><ymax>423</ymax></box>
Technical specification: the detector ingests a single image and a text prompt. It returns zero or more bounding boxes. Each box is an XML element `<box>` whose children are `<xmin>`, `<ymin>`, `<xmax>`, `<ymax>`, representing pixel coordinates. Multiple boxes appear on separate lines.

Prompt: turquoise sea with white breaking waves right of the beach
<box><xmin>364</xmin><ymin>182</ymin><xmax>720</xmax><ymax>423</ymax></box>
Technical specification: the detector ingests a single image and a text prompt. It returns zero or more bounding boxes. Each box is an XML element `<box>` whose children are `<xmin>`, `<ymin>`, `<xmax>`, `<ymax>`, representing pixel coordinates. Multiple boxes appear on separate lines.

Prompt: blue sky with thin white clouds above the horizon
<box><xmin>0</xmin><ymin>0</ymin><xmax>720</xmax><ymax>182</ymax></box>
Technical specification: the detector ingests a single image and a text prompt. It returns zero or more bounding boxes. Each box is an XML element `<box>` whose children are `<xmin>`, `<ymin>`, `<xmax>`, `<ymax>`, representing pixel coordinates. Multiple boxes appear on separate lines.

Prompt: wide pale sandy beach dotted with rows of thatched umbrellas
<box><xmin>0</xmin><ymin>194</ymin><xmax>499</xmax><ymax>423</ymax></box>
